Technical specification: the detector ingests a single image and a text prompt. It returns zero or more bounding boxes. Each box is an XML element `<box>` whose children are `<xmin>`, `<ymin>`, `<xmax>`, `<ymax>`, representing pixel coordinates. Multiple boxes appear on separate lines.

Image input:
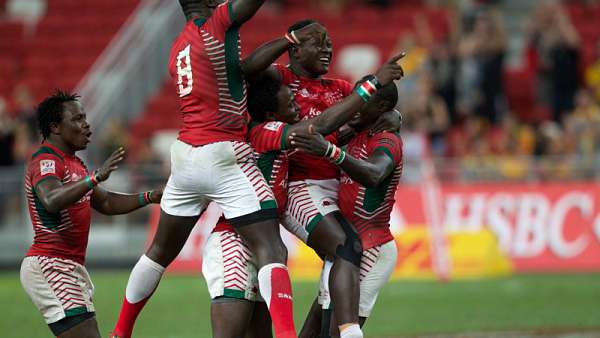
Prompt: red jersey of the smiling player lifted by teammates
<box><xmin>275</xmin><ymin>64</ymin><xmax>353</xmax><ymax>181</ymax></box>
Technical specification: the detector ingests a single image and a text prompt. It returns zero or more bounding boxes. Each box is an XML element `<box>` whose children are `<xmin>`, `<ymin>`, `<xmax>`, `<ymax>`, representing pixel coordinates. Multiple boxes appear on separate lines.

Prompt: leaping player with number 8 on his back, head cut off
<box><xmin>113</xmin><ymin>0</ymin><xmax>322</xmax><ymax>337</ymax></box>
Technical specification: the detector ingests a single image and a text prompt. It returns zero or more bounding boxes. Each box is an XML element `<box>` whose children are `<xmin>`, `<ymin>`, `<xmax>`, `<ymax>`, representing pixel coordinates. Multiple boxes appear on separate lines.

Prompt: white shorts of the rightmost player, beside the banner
<box><xmin>318</xmin><ymin>241</ymin><xmax>398</xmax><ymax>318</ymax></box>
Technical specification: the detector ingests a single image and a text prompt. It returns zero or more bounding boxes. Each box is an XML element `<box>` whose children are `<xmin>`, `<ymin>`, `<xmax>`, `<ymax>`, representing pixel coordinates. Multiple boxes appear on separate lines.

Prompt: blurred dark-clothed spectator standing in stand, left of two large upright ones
<box><xmin>458</xmin><ymin>9</ymin><xmax>506</xmax><ymax>123</ymax></box>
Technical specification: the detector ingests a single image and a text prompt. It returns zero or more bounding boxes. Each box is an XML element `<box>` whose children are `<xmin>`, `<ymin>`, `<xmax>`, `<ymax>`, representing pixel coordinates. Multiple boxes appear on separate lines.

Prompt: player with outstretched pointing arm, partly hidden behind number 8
<box><xmin>202</xmin><ymin>49</ymin><xmax>402</xmax><ymax>337</ymax></box>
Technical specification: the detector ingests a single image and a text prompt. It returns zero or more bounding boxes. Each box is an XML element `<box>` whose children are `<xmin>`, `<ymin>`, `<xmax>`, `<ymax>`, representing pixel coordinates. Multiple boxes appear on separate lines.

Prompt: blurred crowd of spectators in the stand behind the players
<box><xmin>0</xmin><ymin>0</ymin><xmax>600</xmax><ymax>180</ymax></box>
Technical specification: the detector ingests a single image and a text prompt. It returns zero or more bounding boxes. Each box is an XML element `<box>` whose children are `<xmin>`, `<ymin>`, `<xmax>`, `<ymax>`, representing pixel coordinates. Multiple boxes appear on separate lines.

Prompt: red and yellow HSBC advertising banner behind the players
<box><xmin>148</xmin><ymin>182</ymin><xmax>600</xmax><ymax>279</ymax></box>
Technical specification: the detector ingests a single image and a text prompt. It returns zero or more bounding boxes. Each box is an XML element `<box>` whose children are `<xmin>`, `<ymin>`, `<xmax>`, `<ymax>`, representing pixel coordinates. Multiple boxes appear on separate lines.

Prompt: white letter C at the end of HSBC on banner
<box><xmin>548</xmin><ymin>192</ymin><xmax>594</xmax><ymax>258</ymax></box>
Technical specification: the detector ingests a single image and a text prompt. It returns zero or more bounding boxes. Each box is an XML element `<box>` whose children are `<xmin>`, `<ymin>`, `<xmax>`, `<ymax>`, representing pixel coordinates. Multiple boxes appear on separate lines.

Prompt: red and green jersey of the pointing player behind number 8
<box><xmin>213</xmin><ymin>121</ymin><xmax>289</xmax><ymax>232</ymax></box>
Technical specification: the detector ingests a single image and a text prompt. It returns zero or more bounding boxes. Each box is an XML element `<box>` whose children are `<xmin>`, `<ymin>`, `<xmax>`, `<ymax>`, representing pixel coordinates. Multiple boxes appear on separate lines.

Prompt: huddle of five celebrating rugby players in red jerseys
<box><xmin>21</xmin><ymin>0</ymin><xmax>404</xmax><ymax>338</ymax></box>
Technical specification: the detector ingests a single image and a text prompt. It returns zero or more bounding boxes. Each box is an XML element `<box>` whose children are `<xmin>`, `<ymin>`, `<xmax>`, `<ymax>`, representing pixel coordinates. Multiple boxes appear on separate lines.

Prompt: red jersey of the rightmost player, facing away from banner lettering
<box><xmin>338</xmin><ymin>131</ymin><xmax>402</xmax><ymax>250</ymax></box>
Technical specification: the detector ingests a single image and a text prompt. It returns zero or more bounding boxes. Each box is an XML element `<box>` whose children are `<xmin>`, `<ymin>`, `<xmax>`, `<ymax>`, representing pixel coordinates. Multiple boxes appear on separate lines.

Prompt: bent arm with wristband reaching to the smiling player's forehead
<box><xmin>241</xmin><ymin>22</ymin><xmax>326</xmax><ymax>78</ymax></box>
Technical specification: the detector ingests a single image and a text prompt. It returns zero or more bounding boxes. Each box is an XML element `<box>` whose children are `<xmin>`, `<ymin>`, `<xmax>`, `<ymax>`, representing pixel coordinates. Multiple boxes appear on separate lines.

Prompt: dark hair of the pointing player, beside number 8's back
<box><xmin>248</xmin><ymin>74</ymin><xmax>281</xmax><ymax>122</ymax></box>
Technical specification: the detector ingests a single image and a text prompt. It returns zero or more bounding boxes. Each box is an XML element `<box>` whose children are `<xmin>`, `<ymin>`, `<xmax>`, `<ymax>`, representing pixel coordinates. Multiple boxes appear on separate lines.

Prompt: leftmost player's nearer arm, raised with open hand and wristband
<box><xmin>35</xmin><ymin>148</ymin><xmax>124</xmax><ymax>213</ymax></box>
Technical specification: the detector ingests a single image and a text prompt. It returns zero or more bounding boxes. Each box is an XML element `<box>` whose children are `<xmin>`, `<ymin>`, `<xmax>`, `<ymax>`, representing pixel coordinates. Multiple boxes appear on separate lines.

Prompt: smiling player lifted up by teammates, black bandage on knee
<box><xmin>251</xmin><ymin>20</ymin><xmax>403</xmax><ymax>337</ymax></box>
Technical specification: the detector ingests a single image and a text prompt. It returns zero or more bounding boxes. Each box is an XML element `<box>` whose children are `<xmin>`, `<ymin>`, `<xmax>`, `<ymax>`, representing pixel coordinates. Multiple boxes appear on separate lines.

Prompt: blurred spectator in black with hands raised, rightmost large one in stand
<box><xmin>530</xmin><ymin>2</ymin><xmax>580</xmax><ymax>122</ymax></box>
